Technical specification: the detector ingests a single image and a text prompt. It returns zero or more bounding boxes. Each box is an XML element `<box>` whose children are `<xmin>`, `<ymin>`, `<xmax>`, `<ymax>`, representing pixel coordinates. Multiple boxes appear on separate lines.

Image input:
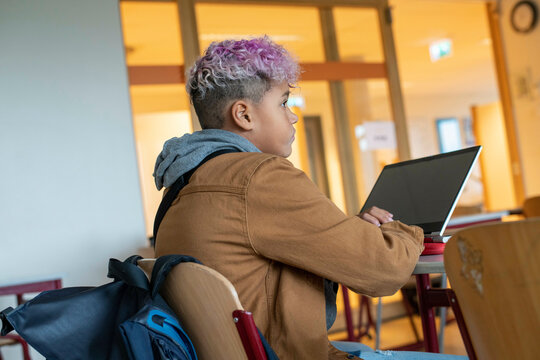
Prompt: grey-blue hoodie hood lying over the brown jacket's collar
<box><xmin>153</xmin><ymin>129</ymin><xmax>261</xmax><ymax>190</ymax></box>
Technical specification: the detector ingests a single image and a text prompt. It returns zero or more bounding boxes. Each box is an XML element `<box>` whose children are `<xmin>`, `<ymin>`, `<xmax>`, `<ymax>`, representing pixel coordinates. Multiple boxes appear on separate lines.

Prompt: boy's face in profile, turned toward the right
<box><xmin>249</xmin><ymin>82</ymin><xmax>298</xmax><ymax>157</ymax></box>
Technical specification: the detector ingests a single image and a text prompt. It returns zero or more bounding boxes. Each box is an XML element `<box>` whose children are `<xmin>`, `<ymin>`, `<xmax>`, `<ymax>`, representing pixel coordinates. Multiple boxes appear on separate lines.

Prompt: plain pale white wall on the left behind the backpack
<box><xmin>0</xmin><ymin>0</ymin><xmax>145</xmax><ymax>355</ymax></box>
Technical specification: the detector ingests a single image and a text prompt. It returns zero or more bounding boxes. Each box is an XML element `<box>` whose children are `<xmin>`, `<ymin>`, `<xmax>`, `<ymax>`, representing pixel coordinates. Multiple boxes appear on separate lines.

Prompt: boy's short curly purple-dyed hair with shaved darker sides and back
<box><xmin>186</xmin><ymin>36</ymin><xmax>300</xmax><ymax>129</ymax></box>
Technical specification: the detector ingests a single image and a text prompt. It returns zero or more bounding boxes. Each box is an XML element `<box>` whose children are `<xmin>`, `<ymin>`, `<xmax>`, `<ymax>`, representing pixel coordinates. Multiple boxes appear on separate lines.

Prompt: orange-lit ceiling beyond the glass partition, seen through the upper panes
<box><xmin>121</xmin><ymin>0</ymin><xmax>497</xmax><ymax>99</ymax></box>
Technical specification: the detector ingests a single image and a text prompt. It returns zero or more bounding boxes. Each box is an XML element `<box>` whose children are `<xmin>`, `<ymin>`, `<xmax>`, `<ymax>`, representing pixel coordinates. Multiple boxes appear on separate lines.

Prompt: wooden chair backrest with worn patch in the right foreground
<box><xmin>444</xmin><ymin>219</ymin><xmax>540</xmax><ymax>359</ymax></box>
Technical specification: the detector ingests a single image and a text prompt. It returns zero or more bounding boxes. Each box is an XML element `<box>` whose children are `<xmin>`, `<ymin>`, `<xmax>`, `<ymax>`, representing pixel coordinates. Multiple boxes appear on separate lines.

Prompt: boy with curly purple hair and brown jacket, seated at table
<box><xmin>154</xmin><ymin>37</ymin><xmax>464</xmax><ymax>360</ymax></box>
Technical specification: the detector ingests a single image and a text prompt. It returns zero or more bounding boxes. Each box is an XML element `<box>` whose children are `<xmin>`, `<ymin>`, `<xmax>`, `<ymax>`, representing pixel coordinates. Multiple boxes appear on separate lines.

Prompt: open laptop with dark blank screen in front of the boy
<box><xmin>362</xmin><ymin>146</ymin><xmax>482</xmax><ymax>242</ymax></box>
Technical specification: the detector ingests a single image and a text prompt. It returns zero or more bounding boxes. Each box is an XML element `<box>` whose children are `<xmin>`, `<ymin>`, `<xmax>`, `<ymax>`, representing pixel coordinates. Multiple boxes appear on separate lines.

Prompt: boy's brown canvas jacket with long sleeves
<box><xmin>156</xmin><ymin>153</ymin><xmax>423</xmax><ymax>360</ymax></box>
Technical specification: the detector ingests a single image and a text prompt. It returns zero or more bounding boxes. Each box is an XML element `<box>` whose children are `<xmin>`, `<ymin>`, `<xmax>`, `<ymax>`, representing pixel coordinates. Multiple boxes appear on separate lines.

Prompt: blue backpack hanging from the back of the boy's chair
<box><xmin>1</xmin><ymin>255</ymin><xmax>198</xmax><ymax>360</ymax></box>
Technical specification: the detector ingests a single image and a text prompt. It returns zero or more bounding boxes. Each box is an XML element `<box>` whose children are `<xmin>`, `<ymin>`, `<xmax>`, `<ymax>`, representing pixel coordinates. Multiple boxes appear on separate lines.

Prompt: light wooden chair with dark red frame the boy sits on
<box><xmin>139</xmin><ymin>259</ymin><xmax>266</xmax><ymax>360</ymax></box>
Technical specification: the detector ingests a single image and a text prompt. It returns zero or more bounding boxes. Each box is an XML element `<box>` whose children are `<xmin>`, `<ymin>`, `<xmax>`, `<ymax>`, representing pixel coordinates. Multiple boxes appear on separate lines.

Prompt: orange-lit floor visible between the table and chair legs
<box><xmin>329</xmin><ymin>316</ymin><xmax>467</xmax><ymax>355</ymax></box>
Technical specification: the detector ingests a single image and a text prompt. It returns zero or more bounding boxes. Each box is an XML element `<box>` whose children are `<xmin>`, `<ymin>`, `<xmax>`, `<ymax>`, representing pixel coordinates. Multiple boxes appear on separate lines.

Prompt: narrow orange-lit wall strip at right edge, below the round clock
<box><xmin>500</xmin><ymin>0</ymin><xmax>540</xmax><ymax>196</ymax></box>
